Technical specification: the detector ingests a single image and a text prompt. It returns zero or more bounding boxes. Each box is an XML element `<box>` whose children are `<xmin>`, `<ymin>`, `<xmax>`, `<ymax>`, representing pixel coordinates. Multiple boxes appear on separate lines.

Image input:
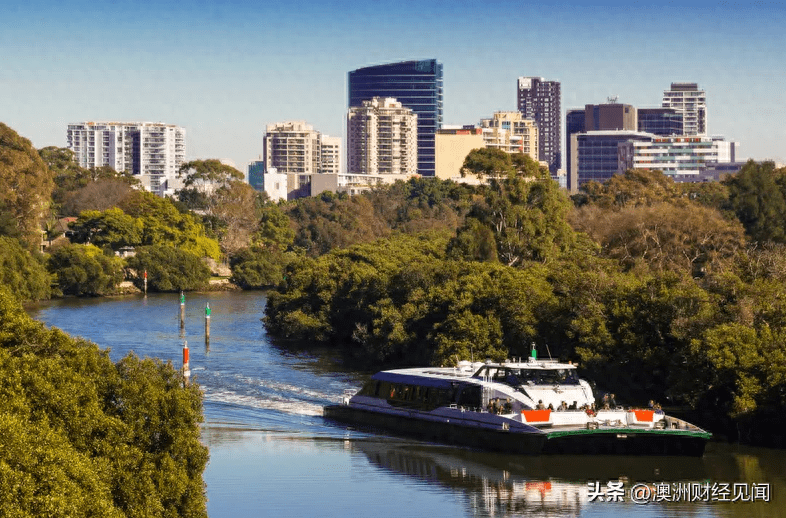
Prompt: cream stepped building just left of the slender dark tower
<box><xmin>480</xmin><ymin>112</ymin><xmax>538</xmax><ymax>161</ymax></box>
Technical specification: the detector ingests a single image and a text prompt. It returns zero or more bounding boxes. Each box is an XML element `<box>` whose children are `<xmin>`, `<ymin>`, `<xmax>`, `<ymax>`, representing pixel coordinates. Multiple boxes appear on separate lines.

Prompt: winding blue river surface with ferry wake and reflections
<box><xmin>28</xmin><ymin>292</ymin><xmax>786</xmax><ymax>518</ymax></box>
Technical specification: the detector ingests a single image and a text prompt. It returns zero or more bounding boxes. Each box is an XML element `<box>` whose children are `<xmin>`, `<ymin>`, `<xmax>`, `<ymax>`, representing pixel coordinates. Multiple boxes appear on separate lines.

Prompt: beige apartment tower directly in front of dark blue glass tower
<box><xmin>347</xmin><ymin>97</ymin><xmax>418</xmax><ymax>175</ymax></box>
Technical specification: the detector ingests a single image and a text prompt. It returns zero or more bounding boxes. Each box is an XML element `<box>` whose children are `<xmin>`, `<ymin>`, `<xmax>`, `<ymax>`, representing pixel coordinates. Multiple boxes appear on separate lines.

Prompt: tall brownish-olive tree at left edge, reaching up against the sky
<box><xmin>0</xmin><ymin>123</ymin><xmax>54</xmax><ymax>250</ymax></box>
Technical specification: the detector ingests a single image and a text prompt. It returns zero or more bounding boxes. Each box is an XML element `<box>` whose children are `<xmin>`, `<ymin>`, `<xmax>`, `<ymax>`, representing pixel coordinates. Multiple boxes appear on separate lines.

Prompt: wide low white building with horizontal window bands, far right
<box><xmin>618</xmin><ymin>135</ymin><xmax>738</xmax><ymax>181</ymax></box>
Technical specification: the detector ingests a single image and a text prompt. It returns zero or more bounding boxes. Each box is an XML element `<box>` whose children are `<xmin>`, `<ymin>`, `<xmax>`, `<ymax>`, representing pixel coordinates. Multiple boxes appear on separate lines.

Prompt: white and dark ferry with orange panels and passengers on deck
<box><xmin>324</xmin><ymin>348</ymin><xmax>711</xmax><ymax>456</ymax></box>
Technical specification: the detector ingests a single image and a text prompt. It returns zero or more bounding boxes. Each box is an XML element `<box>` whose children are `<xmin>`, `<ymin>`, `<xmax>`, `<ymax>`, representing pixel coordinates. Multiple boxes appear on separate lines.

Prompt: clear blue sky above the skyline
<box><xmin>0</xmin><ymin>0</ymin><xmax>786</xmax><ymax>172</ymax></box>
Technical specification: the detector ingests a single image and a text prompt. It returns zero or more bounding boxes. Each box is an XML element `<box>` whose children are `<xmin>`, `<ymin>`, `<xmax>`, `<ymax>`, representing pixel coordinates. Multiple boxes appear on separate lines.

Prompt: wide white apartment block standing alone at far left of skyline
<box><xmin>66</xmin><ymin>122</ymin><xmax>186</xmax><ymax>196</ymax></box>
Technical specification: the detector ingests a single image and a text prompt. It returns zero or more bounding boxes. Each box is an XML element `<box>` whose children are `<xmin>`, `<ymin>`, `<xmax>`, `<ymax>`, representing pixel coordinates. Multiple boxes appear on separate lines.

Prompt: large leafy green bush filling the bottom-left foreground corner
<box><xmin>0</xmin><ymin>286</ymin><xmax>208</xmax><ymax>518</ymax></box>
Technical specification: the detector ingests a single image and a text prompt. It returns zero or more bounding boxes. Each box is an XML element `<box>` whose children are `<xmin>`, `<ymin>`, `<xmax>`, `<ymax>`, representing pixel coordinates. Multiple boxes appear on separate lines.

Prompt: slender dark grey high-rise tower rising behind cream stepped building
<box><xmin>517</xmin><ymin>77</ymin><xmax>562</xmax><ymax>176</ymax></box>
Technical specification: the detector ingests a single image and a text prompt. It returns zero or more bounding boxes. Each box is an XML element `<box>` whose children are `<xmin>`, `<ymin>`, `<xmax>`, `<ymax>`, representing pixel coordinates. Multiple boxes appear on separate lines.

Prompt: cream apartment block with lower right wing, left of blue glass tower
<box><xmin>262</xmin><ymin>121</ymin><xmax>341</xmax><ymax>174</ymax></box>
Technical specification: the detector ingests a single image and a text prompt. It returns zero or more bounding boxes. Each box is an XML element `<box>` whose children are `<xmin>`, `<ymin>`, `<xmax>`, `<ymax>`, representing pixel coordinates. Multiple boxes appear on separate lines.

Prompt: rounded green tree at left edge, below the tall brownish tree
<box><xmin>0</xmin><ymin>236</ymin><xmax>51</xmax><ymax>301</ymax></box>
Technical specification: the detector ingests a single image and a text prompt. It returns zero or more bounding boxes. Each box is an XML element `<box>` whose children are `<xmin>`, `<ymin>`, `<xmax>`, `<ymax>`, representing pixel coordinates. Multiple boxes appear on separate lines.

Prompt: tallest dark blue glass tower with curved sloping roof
<box><xmin>349</xmin><ymin>59</ymin><xmax>442</xmax><ymax>176</ymax></box>
